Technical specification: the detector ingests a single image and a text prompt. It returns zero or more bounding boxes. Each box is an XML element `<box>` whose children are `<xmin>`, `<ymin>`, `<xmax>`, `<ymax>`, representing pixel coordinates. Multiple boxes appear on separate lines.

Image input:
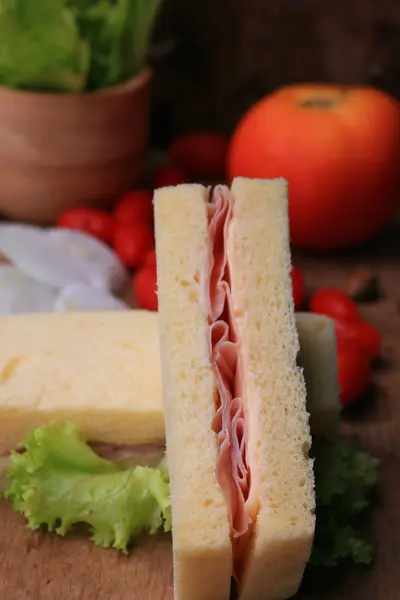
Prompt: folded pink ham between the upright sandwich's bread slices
<box><xmin>207</xmin><ymin>186</ymin><xmax>251</xmax><ymax>539</ymax></box>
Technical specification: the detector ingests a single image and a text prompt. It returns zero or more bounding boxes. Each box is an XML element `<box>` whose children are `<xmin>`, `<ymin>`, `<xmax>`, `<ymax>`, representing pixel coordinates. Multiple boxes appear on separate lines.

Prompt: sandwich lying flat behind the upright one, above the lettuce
<box><xmin>0</xmin><ymin>310</ymin><xmax>339</xmax><ymax>473</ymax></box>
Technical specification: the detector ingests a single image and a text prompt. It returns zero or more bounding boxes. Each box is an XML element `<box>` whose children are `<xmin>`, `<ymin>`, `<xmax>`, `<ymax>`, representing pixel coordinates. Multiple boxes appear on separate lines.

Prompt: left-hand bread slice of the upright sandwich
<box><xmin>154</xmin><ymin>185</ymin><xmax>232</xmax><ymax>600</ymax></box>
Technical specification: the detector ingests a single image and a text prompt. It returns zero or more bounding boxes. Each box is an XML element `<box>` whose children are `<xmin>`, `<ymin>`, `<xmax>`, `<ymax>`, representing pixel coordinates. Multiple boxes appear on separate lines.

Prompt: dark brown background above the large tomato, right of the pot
<box><xmin>150</xmin><ymin>0</ymin><xmax>400</xmax><ymax>145</ymax></box>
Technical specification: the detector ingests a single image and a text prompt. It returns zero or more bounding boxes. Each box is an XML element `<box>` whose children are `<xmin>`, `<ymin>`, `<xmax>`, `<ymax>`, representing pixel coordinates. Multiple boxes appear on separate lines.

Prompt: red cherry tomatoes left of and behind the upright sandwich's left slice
<box><xmin>58</xmin><ymin>132</ymin><xmax>228</xmax><ymax>311</ymax></box>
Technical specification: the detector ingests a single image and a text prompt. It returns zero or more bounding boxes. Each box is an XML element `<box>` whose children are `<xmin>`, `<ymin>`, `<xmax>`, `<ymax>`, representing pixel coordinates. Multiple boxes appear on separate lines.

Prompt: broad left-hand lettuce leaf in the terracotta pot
<box><xmin>0</xmin><ymin>0</ymin><xmax>90</xmax><ymax>92</ymax></box>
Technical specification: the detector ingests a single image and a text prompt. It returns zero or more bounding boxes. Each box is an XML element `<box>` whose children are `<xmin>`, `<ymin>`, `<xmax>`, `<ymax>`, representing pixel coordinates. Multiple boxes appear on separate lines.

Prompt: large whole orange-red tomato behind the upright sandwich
<box><xmin>228</xmin><ymin>84</ymin><xmax>400</xmax><ymax>250</ymax></box>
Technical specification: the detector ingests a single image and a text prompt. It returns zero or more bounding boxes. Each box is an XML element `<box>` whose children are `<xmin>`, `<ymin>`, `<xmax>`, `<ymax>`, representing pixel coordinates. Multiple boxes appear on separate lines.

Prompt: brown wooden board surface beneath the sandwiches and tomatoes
<box><xmin>0</xmin><ymin>231</ymin><xmax>400</xmax><ymax>600</ymax></box>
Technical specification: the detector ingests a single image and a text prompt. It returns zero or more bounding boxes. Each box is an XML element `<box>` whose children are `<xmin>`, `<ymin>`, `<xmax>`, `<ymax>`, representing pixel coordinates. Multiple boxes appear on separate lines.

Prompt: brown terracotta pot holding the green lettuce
<box><xmin>0</xmin><ymin>69</ymin><xmax>151</xmax><ymax>225</ymax></box>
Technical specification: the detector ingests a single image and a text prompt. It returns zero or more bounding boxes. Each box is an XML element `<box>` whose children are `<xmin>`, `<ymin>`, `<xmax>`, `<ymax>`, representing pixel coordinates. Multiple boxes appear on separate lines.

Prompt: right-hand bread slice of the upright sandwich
<box><xmin>228</xmin><ymin>178</ymin><xmax>315</xmax><ymax>600</ymax></box>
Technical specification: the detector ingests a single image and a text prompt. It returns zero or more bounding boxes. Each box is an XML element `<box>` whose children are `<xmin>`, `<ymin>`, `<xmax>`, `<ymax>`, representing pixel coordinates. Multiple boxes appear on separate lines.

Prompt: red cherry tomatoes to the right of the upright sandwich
<box><xmin>292</xmin><ymin>267</ymin><xmax>381</xmax><ymax>406</ymax></box>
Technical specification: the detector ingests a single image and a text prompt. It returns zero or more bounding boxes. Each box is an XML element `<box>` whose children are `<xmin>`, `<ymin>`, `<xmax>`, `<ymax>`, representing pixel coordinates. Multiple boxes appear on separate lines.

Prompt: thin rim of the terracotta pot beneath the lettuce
<box><xmin>0</xmin><ymin>66</ymin><xmax>153</xmax><ymax>104</ymax></box>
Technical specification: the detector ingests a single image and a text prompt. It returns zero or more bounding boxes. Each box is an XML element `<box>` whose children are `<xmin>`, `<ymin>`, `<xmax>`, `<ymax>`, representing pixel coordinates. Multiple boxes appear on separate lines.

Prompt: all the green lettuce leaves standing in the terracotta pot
<box><xmin>0</xmin><ymin>0</ymin><xmax>161</xmax><ymax>93</ymax></box>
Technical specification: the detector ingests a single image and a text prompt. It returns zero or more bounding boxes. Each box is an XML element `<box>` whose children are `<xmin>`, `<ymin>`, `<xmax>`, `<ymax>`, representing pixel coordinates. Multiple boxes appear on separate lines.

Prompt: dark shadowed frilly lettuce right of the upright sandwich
<box><xmin>310</xmin><ymin>439</ymin><xmax>379</xmax><ymax>567</ymax></box>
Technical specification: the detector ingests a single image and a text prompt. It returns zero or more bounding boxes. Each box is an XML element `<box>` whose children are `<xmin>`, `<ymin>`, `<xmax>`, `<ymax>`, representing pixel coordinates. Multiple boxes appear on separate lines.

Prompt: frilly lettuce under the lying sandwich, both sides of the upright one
<box><xmin>5</xmin><ymin>422</ymin><xmax>378</xmax><ymax>567</ymax></box>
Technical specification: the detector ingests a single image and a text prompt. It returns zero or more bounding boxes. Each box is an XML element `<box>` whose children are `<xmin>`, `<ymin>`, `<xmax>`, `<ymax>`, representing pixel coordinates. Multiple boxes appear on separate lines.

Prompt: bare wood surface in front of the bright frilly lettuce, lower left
<box><xmin>0</xmin><ymin>516</ymin><xmax>173</xmax><ymax>600</ymax></box>
